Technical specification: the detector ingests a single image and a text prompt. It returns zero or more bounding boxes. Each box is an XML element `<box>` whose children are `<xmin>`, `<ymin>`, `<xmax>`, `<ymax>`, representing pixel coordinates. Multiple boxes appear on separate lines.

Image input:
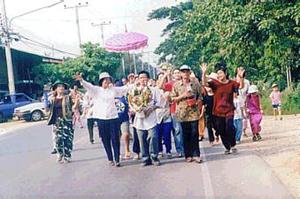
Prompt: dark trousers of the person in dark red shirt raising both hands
<box><xmin>214</xmin><ymin>116</ymin><xmax>236</xmax><ymax>150</ymax></box>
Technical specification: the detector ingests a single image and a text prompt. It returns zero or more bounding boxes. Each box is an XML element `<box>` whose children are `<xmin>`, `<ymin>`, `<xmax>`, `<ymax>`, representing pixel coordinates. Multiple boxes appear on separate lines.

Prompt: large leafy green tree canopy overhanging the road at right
<box><xmin>150</xmin><ymin>0</ymin><xmax>300</xmax><ymax>85</ymax></box>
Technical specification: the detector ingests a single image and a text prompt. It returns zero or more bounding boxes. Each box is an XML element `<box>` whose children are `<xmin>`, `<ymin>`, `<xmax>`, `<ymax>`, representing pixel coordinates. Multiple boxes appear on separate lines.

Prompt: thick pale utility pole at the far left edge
<box><xmin>2</xmin><ymin>0</ymin><xmax>16</xmax><ymax>94</ymax></box>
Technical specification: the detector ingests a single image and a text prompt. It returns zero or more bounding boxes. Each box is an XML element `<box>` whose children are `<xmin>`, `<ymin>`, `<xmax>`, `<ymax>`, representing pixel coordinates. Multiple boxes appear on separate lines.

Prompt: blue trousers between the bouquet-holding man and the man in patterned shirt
<box><xmin>156</xmin><ymin>122</ymin><xmax>172</xmax><ymax>153</ymax></box>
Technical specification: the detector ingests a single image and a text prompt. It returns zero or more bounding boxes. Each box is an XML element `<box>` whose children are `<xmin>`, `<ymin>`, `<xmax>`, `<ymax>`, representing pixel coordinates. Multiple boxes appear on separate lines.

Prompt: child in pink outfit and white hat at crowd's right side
<box><xmin>246</xmin><ymin>85</ymin><xmax>263</xmax><ymax>142</ymax></box>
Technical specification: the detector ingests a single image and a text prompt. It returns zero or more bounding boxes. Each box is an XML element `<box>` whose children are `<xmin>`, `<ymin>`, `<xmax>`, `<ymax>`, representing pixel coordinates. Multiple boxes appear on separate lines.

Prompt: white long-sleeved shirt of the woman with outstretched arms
<box><xmin>82</xmin><ymin>80</ymin><xmax>132</xmax><ymax>120</ymax></box>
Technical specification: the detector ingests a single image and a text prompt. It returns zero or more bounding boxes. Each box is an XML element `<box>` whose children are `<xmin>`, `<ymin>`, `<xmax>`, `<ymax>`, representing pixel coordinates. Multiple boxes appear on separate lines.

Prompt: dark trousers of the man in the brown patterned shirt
<box><xmin>180</xmin><ymin>120</ymin><xmax>200</xmax><ymax>158</ymax></box>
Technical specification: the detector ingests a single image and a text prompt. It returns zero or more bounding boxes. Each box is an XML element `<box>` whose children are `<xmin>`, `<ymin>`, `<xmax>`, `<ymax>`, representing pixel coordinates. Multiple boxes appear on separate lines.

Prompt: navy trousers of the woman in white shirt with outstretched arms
<box><xmin>97</xmin><ymin>119</ymin><xmax>120</xmax><ymax>162</ymax></box>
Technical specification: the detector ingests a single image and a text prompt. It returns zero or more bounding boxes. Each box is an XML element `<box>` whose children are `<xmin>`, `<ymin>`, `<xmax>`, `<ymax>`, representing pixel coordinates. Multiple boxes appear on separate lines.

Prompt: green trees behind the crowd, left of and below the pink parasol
<box><xmin>33</xmin><ymin>43</ymin><xmax>121</xmax><ymax>85</ymax></box>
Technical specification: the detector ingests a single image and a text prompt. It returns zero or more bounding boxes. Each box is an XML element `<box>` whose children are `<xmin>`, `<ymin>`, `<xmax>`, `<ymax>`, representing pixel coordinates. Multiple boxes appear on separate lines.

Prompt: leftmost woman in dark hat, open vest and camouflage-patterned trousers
<box><xmin>48</xmin><ymin>82</ymin><xmax>74</xmax><ymax>163</ymax></box>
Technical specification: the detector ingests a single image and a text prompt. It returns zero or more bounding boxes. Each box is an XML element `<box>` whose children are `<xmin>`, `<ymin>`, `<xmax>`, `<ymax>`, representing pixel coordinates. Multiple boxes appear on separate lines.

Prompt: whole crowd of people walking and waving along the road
<box><xmin>46</xmin><ymin>63</ymin><xmax>282</xmax><ymax>167</ymax></box>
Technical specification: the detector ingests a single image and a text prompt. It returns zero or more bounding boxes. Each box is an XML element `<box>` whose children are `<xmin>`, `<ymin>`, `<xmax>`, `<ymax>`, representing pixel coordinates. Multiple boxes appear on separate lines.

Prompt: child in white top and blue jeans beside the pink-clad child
<box><xmin>233</xmin><ymin>93</ymin><xmax>243</xmax><ymax>144</ymax></box>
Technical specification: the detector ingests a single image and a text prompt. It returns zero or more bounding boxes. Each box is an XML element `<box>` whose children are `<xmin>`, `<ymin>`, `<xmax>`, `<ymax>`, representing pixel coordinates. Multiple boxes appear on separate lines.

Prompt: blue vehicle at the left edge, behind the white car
<box><xmin>0</xmin><ymin>93</ymin><xmax>36</xmax><ymax>123</ymax></box>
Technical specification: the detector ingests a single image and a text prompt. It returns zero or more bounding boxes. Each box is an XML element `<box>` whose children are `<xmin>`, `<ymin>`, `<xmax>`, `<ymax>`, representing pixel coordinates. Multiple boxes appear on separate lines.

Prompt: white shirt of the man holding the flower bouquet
<box><xmin>133</xmin><ymin>87</ymin><xmax>161</xmax><ymax>130</ymax></box>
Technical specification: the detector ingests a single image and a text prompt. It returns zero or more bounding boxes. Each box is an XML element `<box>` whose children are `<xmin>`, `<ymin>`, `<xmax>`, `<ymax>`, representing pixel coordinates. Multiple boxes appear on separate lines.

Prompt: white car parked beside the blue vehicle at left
<box><xmin>14</xmin><ymin>102</ymin><xmax>48</xmax><ymax>122</ymax></box>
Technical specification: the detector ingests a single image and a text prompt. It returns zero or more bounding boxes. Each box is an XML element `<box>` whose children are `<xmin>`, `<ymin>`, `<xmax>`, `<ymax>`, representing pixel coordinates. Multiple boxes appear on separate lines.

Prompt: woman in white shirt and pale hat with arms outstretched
<box><xmin>75</xmin><ymin>72</ymin><xmax>130</xmax><ymax>167</ymax></box>
